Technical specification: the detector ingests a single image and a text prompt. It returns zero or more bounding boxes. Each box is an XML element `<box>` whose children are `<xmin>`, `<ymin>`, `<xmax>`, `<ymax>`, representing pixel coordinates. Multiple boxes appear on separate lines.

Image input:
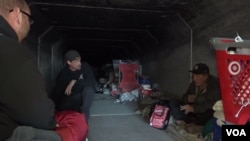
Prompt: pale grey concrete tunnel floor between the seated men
<box><xmin>88</xmin><ymin>93</ymin><xmax>174</xmax><ymax>141</ymax></box>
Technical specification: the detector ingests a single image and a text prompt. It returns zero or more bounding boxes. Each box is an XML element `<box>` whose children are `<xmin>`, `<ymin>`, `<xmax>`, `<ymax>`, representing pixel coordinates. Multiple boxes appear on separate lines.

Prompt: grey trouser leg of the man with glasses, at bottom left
<box><xmin>5</xmin><ymin>126</ymin><xmax>62</xmax><ymax>141</ymax></box>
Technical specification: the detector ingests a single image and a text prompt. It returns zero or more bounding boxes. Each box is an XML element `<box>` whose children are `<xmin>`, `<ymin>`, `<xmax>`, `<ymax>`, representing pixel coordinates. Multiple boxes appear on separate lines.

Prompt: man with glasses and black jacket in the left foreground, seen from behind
<box><xmin>0</xmin><ymin>0</ymin><xmax>61</xmax><ymax>141</ymax></box>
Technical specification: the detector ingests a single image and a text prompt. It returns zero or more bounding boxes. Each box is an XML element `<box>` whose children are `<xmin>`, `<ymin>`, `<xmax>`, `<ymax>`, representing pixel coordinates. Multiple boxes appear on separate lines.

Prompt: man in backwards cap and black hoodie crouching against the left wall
<box><xmin>51</xmin><ymin>50</ymin><xmax>97</xmax><ymax>120</ymax></box>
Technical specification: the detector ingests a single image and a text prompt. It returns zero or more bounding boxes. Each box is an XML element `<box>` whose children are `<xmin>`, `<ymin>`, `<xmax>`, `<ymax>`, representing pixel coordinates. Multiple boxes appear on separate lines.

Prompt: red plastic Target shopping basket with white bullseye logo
<box><xmin>210</xmin><ymin>38</ymin><xmax>250</xmax><ymax>124</ymax></box>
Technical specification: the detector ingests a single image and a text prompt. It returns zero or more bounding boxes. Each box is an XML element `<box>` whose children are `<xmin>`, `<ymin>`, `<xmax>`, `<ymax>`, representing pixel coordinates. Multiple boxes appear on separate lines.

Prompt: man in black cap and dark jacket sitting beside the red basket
<box><xmin>169</xmin><ymin>63</ymin><xmax>221</xmax><ymax>133</ymax></box>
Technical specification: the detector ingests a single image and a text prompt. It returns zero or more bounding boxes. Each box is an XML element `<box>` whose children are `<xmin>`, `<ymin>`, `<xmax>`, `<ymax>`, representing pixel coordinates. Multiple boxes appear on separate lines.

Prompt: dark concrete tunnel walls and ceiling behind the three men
<box><xmin>19</xmin><ymin>0</ymin><xmax>250</xmax><ymax>102</ymax></box>
